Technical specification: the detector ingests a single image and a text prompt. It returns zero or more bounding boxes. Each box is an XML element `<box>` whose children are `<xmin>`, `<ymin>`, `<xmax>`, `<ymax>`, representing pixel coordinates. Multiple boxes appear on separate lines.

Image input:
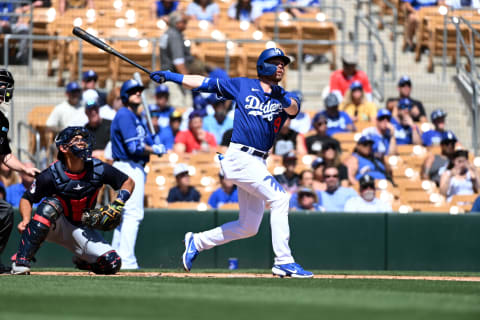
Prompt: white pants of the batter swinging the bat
<box><xmin>194</xmin><ymin>143</ymin><xmax>294</xmax><ymax>264</ymax></box>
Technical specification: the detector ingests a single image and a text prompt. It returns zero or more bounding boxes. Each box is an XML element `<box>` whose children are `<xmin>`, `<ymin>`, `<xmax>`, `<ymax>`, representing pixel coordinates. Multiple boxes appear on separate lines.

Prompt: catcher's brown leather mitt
<box><xmin>82</xmin><ymin>199</ymin><xmax>125</xmax><ymax>231</ymax></box>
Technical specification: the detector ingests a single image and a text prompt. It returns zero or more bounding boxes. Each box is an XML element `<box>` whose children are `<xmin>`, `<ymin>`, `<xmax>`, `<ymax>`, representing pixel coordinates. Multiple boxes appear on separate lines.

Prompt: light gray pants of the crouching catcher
<box><xmin>46</xmin><ymin>215</ymin><xmax>113</xmax><ymax>263</ymax></box>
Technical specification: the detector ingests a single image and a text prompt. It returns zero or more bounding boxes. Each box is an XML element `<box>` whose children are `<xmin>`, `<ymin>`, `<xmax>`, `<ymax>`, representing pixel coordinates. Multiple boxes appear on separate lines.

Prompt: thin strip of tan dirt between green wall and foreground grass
<box><xmin>4</xmin><ymin>271</ymin><xmax>480</xmax><ymax>282</ymax></box>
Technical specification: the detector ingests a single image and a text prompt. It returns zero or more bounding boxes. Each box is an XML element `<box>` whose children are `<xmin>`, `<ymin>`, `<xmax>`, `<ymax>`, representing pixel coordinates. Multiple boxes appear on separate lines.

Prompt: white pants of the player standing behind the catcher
<box><xmin>112</xmin><ymin>161</ymin><xmax>146</xmax><ymax>270</ymax></box>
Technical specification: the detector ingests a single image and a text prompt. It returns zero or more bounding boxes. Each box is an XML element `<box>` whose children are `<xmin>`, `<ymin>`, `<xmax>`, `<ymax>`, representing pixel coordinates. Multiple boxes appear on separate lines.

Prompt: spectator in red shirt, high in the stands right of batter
<box><xmin>330</xmin><ymin>55</ymin><xmax>373</xmax><ymax>101</ymax></box>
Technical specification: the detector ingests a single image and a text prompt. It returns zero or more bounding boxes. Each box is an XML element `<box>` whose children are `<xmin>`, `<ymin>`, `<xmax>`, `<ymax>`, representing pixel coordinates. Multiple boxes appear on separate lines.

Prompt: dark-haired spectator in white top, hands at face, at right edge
<box><xmin>439</xmin><ymin>150</ymin><xmax>480</xmax><ymax>202</ymax></box>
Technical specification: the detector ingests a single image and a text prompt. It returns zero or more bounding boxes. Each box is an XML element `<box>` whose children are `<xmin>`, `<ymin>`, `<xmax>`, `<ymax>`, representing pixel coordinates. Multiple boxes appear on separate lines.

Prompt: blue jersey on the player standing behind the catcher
<box><xmin>110</xmin><ymin>107</ymin><xmax>153</xmax><ymax>164</ymax></box>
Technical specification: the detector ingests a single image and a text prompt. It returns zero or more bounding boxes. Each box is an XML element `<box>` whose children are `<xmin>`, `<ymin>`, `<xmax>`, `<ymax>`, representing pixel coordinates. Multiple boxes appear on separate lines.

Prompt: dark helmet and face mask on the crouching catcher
<box><xmin>55</xmin><ymin>127</ymin><xmax>93</xmax><ymax>161</ymax></box>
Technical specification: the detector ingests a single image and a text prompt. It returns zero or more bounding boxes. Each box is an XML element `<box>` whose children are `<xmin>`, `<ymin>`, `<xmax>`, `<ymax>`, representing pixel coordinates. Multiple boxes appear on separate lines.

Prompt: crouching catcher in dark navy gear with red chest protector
<box><xmin>11</xmin><ymin>127</ymin><xmax>134</xmax><ymax>274</ymax></box>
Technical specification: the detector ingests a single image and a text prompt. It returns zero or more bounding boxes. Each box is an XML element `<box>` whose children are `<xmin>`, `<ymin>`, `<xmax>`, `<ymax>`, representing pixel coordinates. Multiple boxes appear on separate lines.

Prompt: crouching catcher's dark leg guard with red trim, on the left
<box><xmin>16</xmin><ymin>198</ymin><xmax>63</xmax><ymax>266</ymax></box>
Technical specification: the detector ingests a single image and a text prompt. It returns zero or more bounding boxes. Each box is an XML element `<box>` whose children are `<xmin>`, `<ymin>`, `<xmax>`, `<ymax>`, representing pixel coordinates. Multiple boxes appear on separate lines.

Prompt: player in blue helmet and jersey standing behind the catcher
<box><xmin>110</xmin><ymin>79</ymin><xmax>165</xmax><ymax>269</ymax></box>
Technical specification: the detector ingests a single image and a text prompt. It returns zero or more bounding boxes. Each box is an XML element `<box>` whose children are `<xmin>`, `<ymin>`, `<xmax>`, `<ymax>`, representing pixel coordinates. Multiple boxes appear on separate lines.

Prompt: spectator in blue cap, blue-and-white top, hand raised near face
<box><xmin>391</xmin><ymin>98</ymin><xmax>422</xmax><ymax>145</ymax></box>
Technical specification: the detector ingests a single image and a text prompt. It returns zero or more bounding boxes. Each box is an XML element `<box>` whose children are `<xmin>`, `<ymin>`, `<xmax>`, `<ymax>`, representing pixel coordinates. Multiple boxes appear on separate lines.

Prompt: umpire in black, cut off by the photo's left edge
<box><xmin>0</xmin><ymin>69</ymin><xmax>40</xmax><ymax>273</ymax></box>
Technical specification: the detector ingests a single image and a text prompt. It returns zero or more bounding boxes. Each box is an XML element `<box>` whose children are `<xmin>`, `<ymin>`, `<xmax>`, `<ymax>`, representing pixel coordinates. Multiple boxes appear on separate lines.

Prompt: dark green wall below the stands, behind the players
<box><xmin>2</xmin><ymin>210</ymin><xmax>480</xmax><ymax>271</ymax></box>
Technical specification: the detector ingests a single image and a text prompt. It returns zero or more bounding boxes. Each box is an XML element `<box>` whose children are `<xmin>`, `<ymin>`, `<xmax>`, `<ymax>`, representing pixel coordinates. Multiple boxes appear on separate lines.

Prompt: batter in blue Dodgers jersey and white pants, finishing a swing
<box><xmin>150</xmin><ymin>48</ymin><xmax>313</xmax><ymax>278</ymax></box>
